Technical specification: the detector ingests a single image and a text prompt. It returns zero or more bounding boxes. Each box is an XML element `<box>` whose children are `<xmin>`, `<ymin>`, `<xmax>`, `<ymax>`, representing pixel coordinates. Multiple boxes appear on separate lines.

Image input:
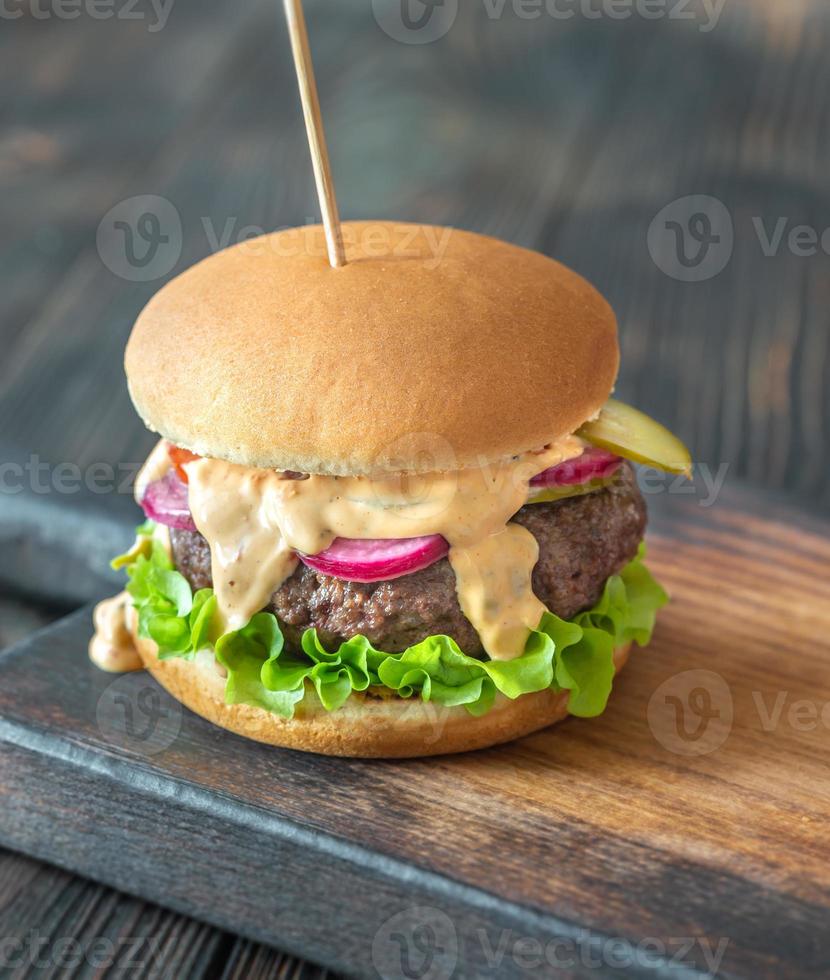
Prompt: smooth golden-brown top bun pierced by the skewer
<box><xmin>126</xmin><ymin>221</ymin><xmax>619</xmax><ymax>475</ymax></box>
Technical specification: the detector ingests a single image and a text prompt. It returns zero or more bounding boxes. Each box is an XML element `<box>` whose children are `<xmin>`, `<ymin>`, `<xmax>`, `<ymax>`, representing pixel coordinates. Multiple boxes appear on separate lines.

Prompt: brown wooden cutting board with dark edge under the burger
<box><xmin>0</xmin><ymin>490</ymin><xmax>830</xmax><ymax>980</ymax></box>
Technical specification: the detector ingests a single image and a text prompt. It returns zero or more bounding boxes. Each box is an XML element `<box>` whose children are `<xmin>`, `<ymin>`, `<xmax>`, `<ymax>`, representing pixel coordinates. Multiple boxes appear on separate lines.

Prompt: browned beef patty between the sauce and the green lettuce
<box><xmin>170</xmin><ymin>463</ymin><xmax>646</xmax><ymax>656</ymax></box>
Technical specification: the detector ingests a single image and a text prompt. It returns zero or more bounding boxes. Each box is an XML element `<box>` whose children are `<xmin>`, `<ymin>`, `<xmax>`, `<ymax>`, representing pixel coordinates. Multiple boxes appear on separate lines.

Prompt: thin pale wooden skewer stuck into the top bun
<box><xmin>284</xmin><ymin>0</ymin><xmax>346</xmax><ymax>269</ymax></box>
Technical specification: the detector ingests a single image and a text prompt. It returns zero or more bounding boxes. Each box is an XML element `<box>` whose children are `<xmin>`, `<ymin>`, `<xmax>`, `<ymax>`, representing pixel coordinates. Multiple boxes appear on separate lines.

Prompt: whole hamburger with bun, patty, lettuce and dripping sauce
<box><xmin>90</xmin><ymin>222</ymin><xmax>690</xmax><ymax>757</ymax></box>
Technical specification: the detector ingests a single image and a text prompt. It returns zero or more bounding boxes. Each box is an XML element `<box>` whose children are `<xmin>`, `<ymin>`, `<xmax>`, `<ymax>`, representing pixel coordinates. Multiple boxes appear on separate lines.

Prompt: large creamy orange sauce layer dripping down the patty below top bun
<box><xmin>185</xmin><ymin>436</ymin><xmax>583</xmax><ymax>660</ymax></box>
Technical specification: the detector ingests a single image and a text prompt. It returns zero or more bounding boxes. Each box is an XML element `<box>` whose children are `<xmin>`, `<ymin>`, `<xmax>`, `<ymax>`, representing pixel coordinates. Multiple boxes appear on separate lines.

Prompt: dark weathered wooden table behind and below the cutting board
<box><xmin>0</xmin><ymin>0</ymin><xmax>830</xmax><ymax>977</ymax></box>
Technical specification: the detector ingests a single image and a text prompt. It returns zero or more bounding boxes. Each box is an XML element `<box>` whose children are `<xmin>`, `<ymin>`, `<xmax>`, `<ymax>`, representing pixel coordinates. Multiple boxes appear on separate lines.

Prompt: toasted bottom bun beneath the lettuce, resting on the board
<box><xmin>131</xmin><ymin>616</ymin><xmax>630</xmax><ymax>759</ymax></box>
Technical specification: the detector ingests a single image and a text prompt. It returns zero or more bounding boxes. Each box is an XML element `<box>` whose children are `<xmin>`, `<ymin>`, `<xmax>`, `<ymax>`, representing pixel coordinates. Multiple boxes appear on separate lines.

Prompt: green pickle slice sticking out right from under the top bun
<box><xmin>577</xmin><ymin>398</ymin><xmax>692</xmax><ymax>476</ymax></box>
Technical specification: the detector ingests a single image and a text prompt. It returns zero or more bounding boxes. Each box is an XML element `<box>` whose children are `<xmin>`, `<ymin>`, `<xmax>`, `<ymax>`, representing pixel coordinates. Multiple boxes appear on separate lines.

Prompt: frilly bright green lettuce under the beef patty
<box><xmin>122</xmin><ymin>522</ymin><xmax>668</xmax><ymax>718</ymax></box>
